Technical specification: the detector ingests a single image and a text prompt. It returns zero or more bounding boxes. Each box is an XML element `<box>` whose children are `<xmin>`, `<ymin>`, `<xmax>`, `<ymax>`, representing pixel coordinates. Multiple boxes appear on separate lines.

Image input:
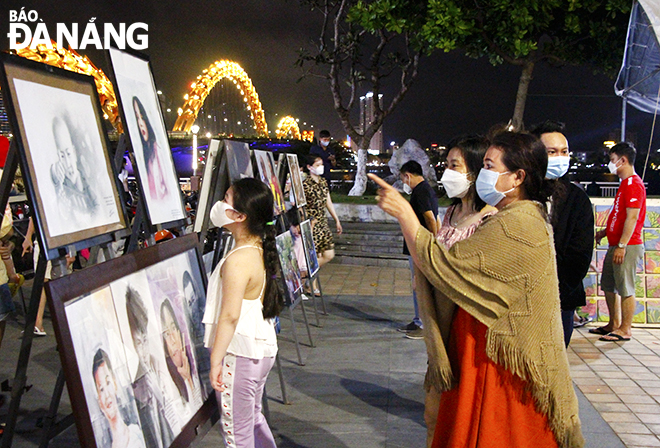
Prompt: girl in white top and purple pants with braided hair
<box><xmin>202</xmin><ymin>178</ymin><xmax>284</xmax><ymax>448</ymax></box>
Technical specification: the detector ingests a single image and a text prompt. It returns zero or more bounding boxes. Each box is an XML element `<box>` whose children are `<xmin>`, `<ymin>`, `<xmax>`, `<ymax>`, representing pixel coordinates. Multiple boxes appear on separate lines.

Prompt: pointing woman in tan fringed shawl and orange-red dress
<box><xmin>369</xmin><ymin>132</ymin><xmax>584</xmax><ymax>448</ymax></box>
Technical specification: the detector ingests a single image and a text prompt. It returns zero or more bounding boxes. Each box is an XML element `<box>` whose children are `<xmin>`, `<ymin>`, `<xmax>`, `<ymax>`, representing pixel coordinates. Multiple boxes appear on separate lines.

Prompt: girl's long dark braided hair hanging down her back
<box><xmin>232</xmin><ymin>178</ymin><xmax>284</xmax><ymax>319</ymax></box>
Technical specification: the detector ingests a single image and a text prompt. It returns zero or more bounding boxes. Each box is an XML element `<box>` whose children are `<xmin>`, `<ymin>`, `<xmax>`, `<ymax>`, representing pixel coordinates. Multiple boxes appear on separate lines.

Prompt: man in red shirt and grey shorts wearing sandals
<box><xmin>589</xmin><ymin>142</ymin><xmax>646</xmax><ymax>341</ymax></box>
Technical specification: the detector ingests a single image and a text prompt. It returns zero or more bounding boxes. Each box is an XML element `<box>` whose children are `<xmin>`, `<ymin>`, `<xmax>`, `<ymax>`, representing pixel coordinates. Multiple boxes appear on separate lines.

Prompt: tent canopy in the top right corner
<box><xmin>614</xmin><ymin>0</ymin><xmax>660</xmax><ymax>113</ymax></box>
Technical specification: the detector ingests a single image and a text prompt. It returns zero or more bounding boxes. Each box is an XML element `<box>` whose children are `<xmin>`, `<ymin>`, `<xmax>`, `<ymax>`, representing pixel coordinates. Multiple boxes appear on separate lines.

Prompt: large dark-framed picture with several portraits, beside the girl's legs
<box><xmin>45</xmin><ymin>234</ymin><xmax>217</xmax><ymax>448</ymax></box>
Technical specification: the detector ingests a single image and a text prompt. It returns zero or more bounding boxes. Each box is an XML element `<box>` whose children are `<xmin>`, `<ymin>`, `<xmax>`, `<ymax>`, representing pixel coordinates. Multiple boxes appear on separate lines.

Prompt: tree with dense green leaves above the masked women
<box><xmin>424</xmin><ymin>0</ymin><xmax>630</xmax><ymax>129</ymax></box>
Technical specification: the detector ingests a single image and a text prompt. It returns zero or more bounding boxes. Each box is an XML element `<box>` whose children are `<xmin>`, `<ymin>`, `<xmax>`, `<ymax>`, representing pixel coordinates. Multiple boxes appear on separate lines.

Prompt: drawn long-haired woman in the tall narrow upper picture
<box><xmin>133</xmin><ymin>96</ymin><xmax>168</xmax><ymax>201</ymax></box>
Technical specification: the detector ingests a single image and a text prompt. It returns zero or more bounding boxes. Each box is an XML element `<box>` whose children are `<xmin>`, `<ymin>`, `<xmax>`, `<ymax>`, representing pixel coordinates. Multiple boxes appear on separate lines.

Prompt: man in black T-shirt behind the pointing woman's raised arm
<box><xmin>398</xmin><ymin>160</ymin><xmax>438</xmax><ymax>339</ymax></box>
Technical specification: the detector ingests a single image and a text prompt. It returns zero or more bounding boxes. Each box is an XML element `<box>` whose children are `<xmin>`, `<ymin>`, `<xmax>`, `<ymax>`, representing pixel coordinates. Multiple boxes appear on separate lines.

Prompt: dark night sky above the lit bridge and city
<box><xmin>0</xmin><ymin>0</ymin><xmax>660</xmax><ymax>152</ymax></box>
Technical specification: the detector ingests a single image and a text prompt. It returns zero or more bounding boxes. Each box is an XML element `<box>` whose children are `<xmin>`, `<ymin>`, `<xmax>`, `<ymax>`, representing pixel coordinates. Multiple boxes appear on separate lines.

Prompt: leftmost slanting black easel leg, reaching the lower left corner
<box><xmin>2</xmin><ymin>251</ymin><xmax>46</xmax><ymax>448</ymax></box>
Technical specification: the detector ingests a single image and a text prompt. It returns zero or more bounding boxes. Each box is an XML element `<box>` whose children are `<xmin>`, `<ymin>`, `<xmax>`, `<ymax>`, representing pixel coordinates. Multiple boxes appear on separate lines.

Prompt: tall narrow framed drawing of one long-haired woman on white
<box><xmin>108</xmin><ymin>48</ymin><xmax>186</xmax><ymax>228</ymax></box>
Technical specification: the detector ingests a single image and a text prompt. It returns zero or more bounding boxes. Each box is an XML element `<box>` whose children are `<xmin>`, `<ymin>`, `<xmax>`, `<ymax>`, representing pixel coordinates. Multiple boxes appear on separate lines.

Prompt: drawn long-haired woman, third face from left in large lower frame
<box><xmin>160</xmin><ymin>299</ymin><xmax>202</xmax><ymax>416</ymax></box>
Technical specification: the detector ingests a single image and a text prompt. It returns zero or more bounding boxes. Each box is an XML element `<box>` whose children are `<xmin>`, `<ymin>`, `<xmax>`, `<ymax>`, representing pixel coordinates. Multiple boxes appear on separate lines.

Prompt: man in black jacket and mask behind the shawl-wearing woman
<box><xmin>532</xmin><ymin>120</ymin><xmax>594</xmax><ymax>347</ymax></box>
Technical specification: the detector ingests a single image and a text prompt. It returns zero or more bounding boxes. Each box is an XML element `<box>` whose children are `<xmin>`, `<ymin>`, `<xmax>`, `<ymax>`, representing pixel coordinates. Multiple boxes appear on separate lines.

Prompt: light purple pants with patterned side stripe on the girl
<box><xmin>215</xmin><ymin>354</ymin><xmax>276</xmax><ymax>448</ymax></box>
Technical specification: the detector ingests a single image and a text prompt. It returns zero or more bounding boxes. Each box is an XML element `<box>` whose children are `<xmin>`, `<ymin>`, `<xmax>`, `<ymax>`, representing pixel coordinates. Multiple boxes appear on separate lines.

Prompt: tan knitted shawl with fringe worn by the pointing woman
<box><xmin>416</xmin><ymin>201</ymin><xmax>584</xmax><ymax>448</ymax></box>
